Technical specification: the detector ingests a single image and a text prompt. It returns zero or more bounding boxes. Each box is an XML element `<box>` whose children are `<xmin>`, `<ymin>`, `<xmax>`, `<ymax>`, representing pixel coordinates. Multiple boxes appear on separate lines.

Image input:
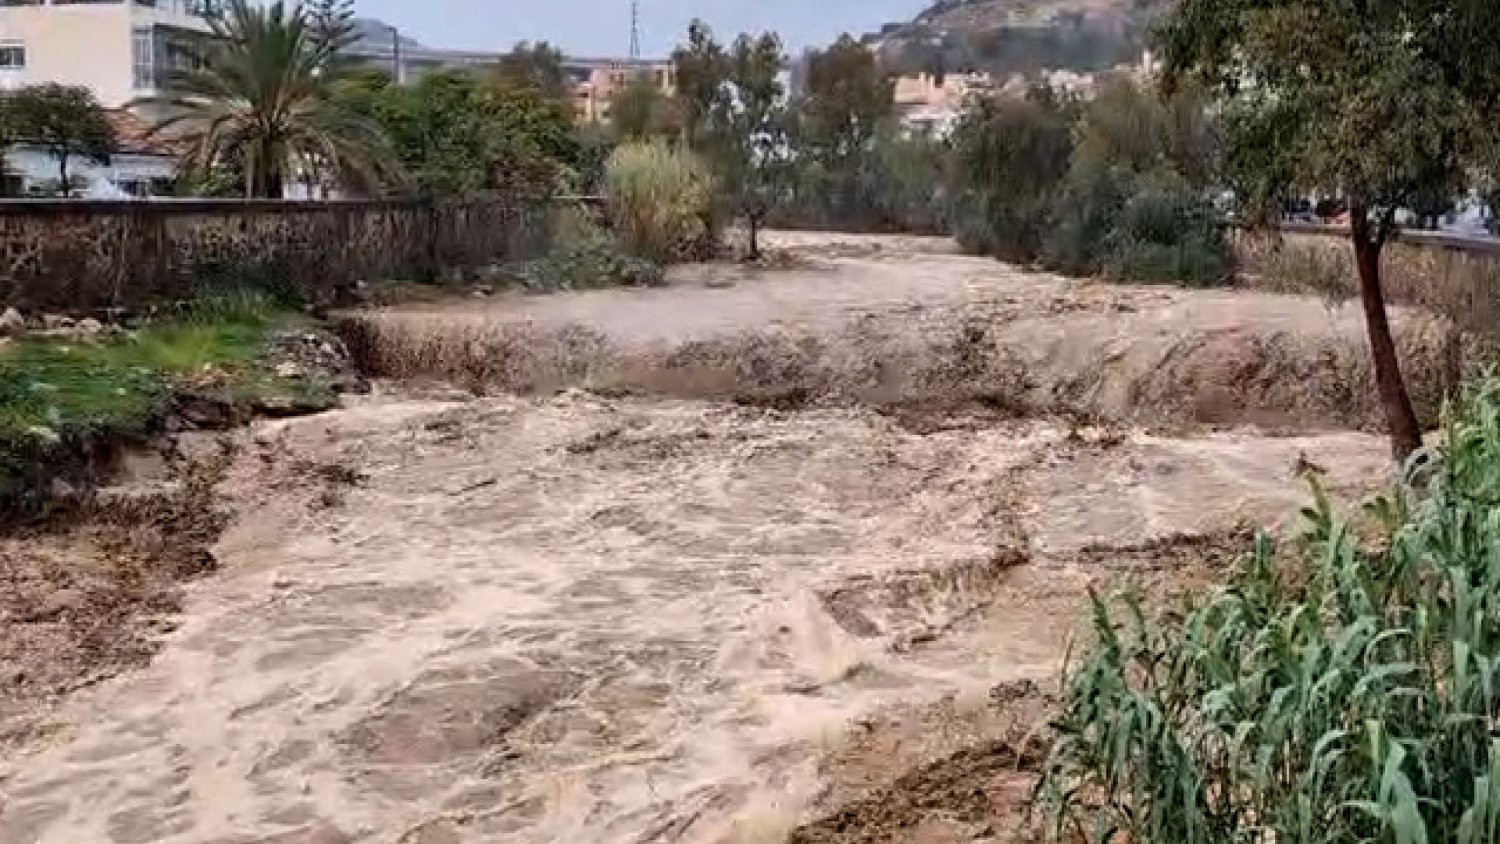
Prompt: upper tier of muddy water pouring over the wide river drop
<box><xmin>347</xmin><ymin>234</ymin><xmax>1463</xmax><ymax>440</ymax></box>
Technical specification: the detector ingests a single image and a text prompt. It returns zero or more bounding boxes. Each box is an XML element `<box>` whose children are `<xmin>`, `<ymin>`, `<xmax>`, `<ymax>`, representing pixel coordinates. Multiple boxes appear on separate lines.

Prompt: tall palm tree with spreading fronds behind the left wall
<box><xmin>138</xmin><ymin>0</ymin><xmax>399</xmax><ymax>198</ymax></box>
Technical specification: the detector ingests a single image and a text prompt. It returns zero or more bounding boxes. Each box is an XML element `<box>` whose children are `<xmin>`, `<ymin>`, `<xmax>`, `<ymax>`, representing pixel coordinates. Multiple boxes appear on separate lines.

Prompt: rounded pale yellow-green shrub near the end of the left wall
<box><xmin>605</xmin><ymin>141</ymin><xmax>717</xmax><ymax>262</ymax></box>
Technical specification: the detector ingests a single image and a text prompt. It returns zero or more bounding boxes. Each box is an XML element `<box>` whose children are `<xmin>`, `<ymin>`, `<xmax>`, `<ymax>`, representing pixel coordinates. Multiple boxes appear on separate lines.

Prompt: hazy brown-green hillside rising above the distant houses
<box><xmin>867</xmin><ymin>0</ymin><xmax>1172</xmax><ymax>76</ymax></box>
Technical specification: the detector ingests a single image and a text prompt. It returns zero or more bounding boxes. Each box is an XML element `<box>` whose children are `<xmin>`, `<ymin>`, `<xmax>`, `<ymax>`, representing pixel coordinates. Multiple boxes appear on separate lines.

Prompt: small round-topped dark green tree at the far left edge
<box><xmin>5</xmin><ymin>82</ymin><xmax>117</xmax><ymax>196</ymax></box>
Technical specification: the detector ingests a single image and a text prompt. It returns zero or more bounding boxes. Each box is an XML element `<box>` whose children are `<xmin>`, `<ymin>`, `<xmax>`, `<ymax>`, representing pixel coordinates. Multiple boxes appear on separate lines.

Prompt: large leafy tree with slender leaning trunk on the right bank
<box><xmin>1163</xmin><ymin>0</ymin><xmax>1500</xmax><ymax>459</ymax></box>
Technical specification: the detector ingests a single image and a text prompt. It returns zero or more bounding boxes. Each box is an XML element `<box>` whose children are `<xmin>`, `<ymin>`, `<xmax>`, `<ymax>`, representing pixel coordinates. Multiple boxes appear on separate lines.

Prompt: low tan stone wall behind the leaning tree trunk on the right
<box><xmin>1230</xmin><ymin>226</ymin><xmax>1500</xmax><ymax>337</ymax></box>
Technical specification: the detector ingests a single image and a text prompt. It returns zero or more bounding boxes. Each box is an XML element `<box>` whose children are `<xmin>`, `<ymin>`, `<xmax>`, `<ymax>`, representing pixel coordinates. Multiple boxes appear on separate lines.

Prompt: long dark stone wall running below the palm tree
<box><xmin>0</xmin><ymin>198</ymin><xmax>551</xmax><ymax>312</ymax></box>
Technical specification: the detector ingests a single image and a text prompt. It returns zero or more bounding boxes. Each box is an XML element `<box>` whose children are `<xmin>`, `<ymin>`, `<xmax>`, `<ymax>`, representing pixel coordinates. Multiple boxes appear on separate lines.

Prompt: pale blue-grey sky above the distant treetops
<box><xmin>356</xmin><ymin>0</ymin><xmax>929</xmax><ymax>55</ymax></box>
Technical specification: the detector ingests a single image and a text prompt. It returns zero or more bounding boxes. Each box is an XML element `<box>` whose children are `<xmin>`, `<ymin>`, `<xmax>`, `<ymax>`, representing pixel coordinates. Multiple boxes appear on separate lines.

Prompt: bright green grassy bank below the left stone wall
<box><xmin>0</xmin><ymin>298</ymin><xmax>348</xmax><ymax>517</ymax></box>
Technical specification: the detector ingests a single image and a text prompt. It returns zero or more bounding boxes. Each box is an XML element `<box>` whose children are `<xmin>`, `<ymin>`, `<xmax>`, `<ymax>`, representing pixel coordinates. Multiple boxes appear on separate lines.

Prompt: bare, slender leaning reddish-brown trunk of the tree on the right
<box><xmin>1349</xmin><ymin>204</ymin><xmax>1422</xmax><ymax>462</ymax></box>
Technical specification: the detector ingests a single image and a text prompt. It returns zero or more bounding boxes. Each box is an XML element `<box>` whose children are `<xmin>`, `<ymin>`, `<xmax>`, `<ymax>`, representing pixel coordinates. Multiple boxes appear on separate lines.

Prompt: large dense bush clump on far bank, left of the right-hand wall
<box><xmin>953</xmin><ymin>73</ymin><xmax>1229</xmax><ymax>286</ymax></box>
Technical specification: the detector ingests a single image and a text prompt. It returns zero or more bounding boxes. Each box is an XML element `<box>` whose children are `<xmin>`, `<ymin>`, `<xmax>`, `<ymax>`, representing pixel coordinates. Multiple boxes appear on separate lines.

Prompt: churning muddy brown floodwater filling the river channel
<box><xmin>0</xmin><ymin>235</ymin><xmax>1388</xmax><ymax>844</ymax></box>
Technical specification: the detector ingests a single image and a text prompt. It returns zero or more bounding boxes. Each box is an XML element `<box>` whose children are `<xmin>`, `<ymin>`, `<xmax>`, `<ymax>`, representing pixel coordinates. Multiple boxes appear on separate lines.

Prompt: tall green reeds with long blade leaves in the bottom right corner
<box><xmin>1040</xmin><ymin>381</ymin><xmax>1500</xmax><ymax>844</ymax></box>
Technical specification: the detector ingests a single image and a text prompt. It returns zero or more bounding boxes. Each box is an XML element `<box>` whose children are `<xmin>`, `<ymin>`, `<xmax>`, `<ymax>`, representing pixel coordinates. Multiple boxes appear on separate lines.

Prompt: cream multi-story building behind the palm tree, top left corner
<box><xmin>0</xmin><ymin>0</ymin><xmax>216</xmax><ymax>108</ymax></box>
